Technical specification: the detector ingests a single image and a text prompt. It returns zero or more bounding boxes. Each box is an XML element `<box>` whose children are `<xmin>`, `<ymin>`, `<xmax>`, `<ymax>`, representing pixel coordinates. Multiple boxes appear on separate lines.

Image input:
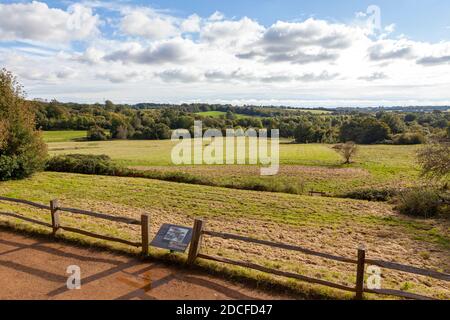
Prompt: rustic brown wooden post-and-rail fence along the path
<box><xmin>0</xmin><ymin>196</ymin><xmax>450</xmax><ymax>300</ymax></box>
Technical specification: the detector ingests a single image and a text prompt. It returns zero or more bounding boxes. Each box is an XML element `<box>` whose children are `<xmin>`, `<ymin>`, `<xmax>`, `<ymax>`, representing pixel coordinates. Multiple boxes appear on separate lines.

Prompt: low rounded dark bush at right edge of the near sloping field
<box><xmin>395</xmin><ymin>187</ymin><xmax>448</xmax><ymax>218</ymax></box>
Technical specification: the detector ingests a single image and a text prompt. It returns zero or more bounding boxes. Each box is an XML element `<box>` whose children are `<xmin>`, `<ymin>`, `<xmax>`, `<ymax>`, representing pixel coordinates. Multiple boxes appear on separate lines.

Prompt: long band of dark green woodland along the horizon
<box><xmin>31</xmin><ymin>100</ymin><xmax>450</xmax><ymax>144</ymax></box>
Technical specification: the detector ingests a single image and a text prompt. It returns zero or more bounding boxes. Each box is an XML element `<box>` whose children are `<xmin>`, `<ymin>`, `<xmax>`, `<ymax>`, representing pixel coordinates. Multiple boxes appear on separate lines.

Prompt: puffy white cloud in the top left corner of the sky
<box><xmin>0</xmin><ymin>1</ymin><xmax>100</xmax><ymax>44</ymax></box>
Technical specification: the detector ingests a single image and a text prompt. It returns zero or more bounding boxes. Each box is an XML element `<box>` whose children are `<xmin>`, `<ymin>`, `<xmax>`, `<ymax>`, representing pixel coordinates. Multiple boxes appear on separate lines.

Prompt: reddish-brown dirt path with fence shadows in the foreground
<box><xmin>0</xmin><ymin>230</ymin><xmax>283</xmax><ymax>300</ymax></box>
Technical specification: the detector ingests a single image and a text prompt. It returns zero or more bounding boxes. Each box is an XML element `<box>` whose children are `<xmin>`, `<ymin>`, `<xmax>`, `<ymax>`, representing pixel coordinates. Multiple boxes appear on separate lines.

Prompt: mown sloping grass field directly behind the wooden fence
<box><xmin>0</xmin><ymin>172</ymin><xmax>450</xmax><ymax>299</ymax></box>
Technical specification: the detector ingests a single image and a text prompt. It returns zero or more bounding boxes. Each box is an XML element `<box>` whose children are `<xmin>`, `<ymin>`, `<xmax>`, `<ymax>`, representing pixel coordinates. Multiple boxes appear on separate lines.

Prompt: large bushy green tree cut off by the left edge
<box><xmin>0</xmin><ymin>69</ymin><xmax>47</xmax><ymax>180</ymax></box>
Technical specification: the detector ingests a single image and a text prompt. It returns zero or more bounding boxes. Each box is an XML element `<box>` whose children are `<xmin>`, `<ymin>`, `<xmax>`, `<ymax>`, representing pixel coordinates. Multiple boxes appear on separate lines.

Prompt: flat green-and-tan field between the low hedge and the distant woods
<box><xmin>49</xmin><ymin>140</ymin><xmax>419</xmax><ymax>195</ymax></box>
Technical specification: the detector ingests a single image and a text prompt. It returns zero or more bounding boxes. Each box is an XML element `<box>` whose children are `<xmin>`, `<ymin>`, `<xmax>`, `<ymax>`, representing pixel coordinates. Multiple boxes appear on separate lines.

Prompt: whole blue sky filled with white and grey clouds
<box><xmin>0</xmin><ymin>0</ymin><xmax>450</xmax><ymax>106</ymax></box>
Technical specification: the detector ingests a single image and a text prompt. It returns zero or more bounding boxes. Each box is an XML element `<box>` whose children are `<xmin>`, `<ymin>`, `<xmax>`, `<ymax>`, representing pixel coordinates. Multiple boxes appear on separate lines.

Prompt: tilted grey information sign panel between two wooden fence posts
<box><xmin>150</xmin><ymin>223</ymin><xmax>192</xmax><ymax>252</ymax></box>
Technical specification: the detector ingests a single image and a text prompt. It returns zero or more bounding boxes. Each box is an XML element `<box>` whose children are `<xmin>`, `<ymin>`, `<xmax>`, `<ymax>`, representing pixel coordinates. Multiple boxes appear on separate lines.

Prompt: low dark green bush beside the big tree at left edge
<box><xmin>46</xmin><ymin>154</ymin><xmax>122</xmax><ymax>175</ymax></box>
